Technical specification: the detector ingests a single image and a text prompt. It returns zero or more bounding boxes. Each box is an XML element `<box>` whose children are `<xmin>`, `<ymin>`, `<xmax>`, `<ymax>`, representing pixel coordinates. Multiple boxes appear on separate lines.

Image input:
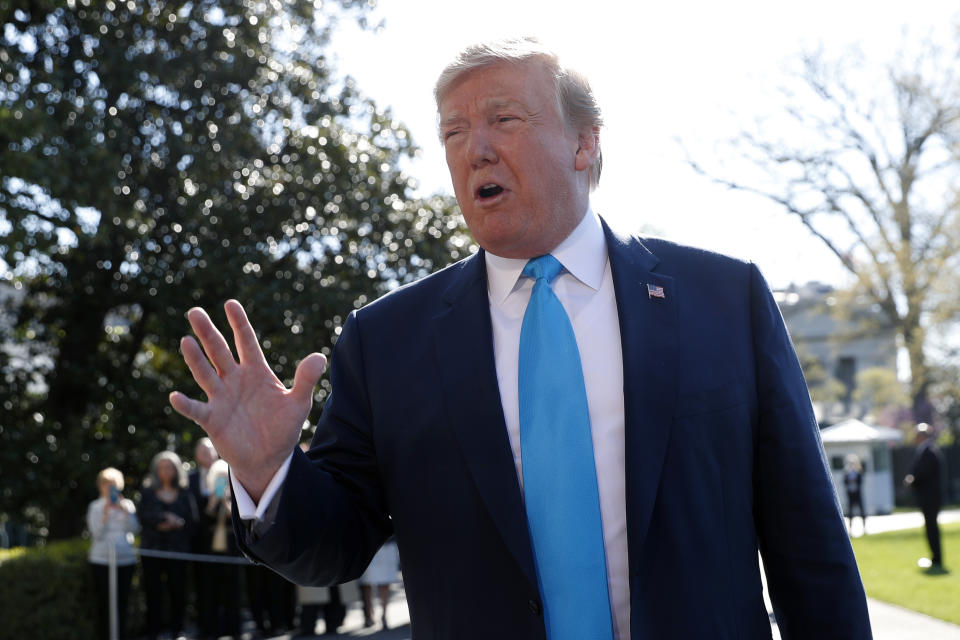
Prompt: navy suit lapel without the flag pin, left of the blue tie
<box><xmin>434</xmin><ymin>251</ymin><xmax>537</xmax><ymax>585</ymax></box>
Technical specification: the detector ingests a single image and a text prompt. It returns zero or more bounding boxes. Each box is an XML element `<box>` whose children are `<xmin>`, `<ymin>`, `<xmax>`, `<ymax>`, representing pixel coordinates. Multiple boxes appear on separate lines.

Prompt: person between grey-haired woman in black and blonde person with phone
<box><xmin>187</xmin><ymin>438</ymin><xmax>219</xmax><ymax>637</ymax></box>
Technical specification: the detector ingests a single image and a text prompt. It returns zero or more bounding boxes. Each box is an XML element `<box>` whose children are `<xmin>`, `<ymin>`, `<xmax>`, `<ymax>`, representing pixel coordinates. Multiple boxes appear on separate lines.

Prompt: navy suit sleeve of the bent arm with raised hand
<box><xmin>233</xmin><ymin>313</ymin><xmax>392</xmax><ymax>586</ymax></box>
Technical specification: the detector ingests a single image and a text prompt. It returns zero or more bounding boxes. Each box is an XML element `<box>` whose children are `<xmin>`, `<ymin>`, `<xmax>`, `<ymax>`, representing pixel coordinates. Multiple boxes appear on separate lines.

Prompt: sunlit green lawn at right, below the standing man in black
<box><xmin>853</xmin><ymin>523</ymin><xmax>960</xmax><ymax>624</ymax></box>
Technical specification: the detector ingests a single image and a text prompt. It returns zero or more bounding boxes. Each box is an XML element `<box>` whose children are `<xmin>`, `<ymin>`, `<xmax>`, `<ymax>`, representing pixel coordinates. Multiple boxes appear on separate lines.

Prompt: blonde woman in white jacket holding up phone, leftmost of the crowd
<box><xmin>87</xmin><ymin>467</ymin><xmax>138</xmax><ymax>638</ymax></box>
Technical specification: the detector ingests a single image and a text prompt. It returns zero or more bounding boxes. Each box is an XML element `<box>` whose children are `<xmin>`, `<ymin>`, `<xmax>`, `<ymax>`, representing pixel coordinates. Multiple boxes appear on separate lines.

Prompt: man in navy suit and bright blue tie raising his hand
<box><xmin>171</xmin><ymin>40</ymin><xmax>870</xmax><ymax>640</ymax></box>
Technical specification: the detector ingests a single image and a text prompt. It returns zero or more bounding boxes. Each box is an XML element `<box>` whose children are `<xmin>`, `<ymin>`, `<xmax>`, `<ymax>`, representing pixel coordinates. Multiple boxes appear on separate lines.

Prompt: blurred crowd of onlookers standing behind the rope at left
<box><xmin>87</xmin><ymin>438</ymin><xmax>399</xmax><ymax>640</ymax></box>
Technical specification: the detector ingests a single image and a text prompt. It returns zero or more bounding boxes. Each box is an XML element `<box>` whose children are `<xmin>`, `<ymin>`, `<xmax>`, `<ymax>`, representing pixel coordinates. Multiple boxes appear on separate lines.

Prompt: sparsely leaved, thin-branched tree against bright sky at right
<box><xmin>691</xmin><ymin>30</ymin><xmax>960</xmax><ymax>420</ymax></box>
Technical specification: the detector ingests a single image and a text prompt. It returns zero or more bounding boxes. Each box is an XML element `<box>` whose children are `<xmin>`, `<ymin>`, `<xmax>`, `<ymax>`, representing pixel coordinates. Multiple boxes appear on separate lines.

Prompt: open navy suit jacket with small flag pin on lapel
<box><xmin>234</xmin><ymin>219</ymin><xmax>870</xmax><ymax>640</ymax></box>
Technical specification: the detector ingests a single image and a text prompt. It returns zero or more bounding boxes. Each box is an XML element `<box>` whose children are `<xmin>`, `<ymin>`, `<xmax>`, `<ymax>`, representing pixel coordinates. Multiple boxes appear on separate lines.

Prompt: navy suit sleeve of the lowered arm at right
<box><xmin>751</xmin><ymin>265</ymin><xmax>871</xmax><ymax>640</ymax></box>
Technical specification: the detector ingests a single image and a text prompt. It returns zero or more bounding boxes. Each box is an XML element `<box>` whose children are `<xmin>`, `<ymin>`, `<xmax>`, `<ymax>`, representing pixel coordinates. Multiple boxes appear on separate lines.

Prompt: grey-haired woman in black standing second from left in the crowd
<box><xmin>140</xmin><ymin>451</ymin><xmax>199</xmax><ymax>639</ymax></box>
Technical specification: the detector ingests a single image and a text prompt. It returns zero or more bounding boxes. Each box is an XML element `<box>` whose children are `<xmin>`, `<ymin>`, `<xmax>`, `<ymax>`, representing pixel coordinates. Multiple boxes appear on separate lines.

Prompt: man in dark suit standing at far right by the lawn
<box><xmin>904</xmin><ymin>422</ymin><xmax>943</xmax><ymax>571</ymax></box>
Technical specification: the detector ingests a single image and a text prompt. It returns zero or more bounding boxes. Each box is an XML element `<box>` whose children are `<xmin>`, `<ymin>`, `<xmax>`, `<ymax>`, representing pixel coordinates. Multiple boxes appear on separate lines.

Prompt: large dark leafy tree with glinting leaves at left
<box><xmin>0</xmin><ymin>0</ymin><xmax>476</xmax><ymax>537</ymax></box>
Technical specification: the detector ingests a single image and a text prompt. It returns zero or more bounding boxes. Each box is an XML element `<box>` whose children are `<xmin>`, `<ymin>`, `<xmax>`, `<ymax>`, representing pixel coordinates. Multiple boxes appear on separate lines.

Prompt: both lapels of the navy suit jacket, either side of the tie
<box><xmin>433</xmin><ymin>222</ymin><xmax>679</xmax><ymax>585</ymax></box>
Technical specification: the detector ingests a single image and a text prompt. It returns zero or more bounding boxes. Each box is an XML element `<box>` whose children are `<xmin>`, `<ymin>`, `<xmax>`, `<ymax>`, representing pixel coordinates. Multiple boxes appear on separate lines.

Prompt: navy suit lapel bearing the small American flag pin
<box><xmin>603</xmin><ymin>222</ymin><xmax>679</xmax><ymax>570</ymax></box>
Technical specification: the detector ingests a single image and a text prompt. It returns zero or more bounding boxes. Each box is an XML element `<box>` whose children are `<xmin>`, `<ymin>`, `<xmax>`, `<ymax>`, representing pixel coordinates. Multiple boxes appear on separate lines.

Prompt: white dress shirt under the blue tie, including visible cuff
<box><xmin>233</xmin><ymin>208</ymin><xmax>630</xmax><ymax>640</ymax></box>
